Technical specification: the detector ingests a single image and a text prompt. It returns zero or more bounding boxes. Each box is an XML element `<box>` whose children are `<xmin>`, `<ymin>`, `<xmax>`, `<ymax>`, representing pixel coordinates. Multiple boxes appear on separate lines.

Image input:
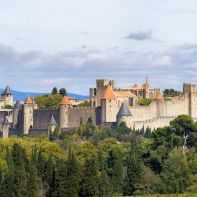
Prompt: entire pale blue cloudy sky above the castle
<box><xmin>0</xmin><ymin>0</ymin><xmax>197</xmax><ymax>94</ymax></box>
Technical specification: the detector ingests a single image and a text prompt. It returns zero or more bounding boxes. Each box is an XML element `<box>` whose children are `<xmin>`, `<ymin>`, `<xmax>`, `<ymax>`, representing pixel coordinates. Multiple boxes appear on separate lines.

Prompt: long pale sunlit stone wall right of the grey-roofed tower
<box><xmin>122</xmin><ymin>93</ymin><xmax>197</xmax><ymax>130</ymax></box>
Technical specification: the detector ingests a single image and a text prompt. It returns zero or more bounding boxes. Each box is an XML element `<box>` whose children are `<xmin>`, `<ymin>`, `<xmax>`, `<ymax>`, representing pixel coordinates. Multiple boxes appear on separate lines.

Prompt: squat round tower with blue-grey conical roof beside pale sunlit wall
<box><xmin>117</xmin><ymin>103</ymin><xmax>132</xmax><ymax>127</ymax></box>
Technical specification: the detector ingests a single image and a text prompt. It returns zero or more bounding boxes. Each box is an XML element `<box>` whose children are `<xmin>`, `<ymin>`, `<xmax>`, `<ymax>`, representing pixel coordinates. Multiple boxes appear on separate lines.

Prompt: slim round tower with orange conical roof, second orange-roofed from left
<box><xmin>60</xmin><ymin>96</ymin><xmax>72</xmax><ymax>129</ymax></box>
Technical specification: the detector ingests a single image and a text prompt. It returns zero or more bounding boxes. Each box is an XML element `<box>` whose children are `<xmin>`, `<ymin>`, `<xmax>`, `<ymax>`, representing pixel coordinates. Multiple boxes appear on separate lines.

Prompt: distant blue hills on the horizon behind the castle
<box><xmin>0</xmin><ymin>88</ymin><xmax>89</xmax><ymax>101</ymax></box>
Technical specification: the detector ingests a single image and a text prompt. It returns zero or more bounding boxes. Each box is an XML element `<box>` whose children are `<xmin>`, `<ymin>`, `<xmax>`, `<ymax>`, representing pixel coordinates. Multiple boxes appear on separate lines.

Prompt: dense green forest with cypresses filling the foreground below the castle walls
<box><xmin>0</xmin><ymin>115</ymin><xmax>197</xmax><ymax>197</ymax></box>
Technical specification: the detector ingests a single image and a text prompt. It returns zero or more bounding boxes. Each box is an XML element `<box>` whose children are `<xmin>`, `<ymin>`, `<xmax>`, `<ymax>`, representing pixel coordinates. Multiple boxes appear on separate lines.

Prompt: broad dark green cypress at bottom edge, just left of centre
<box><xmin>80</xmin><ymin>158</ymin><xmax>98</xmax><ymax>197</ymax></box>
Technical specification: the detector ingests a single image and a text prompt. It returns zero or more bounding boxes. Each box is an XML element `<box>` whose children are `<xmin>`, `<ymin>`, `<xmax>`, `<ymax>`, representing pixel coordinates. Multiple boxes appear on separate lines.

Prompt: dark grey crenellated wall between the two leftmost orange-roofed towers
<box><xmin>33</xmin><ymin>109</ymin><xmax>60</xmax><ymax>129</ymax></box>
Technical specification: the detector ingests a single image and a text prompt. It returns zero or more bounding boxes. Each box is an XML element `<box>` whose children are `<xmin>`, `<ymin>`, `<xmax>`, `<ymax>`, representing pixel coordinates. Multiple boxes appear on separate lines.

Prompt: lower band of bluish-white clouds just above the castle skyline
<box><xmin>0</xmin><ymin>42</ymin><xmax>197</xmax><ymax>94</ymax></box>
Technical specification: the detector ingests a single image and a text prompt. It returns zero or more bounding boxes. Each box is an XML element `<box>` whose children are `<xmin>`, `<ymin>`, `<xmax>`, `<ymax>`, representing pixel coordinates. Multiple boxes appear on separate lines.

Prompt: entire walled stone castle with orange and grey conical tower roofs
<box><xmin>0</xmin><ymin>79</ymin><xmax>197</xmax><ymax>138</ymax></box>
